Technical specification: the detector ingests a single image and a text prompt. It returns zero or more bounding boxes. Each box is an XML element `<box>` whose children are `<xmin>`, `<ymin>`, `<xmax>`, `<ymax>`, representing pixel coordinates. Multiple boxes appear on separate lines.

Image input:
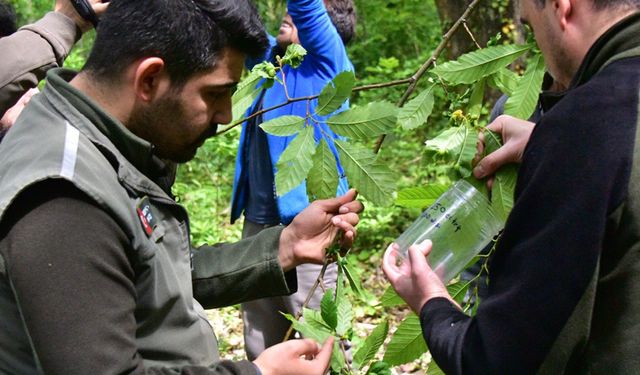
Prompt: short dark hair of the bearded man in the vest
<box><xmin>83</xmin><ymin>0</ymin><xmax>269</xmax><ymax>86</ymax></box>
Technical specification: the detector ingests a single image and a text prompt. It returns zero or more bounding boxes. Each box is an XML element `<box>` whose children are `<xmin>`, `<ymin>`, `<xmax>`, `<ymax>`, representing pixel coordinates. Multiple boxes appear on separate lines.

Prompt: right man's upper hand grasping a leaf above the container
<box><xmin>473</xmin><ymin>115</ymin><xmax>535</xmax><ymax>179</ymax></box>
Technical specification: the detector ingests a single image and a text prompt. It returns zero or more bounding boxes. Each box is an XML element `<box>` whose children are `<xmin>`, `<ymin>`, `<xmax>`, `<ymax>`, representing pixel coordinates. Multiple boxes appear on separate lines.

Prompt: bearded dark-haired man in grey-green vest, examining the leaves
<box><xmin>0</xmin><ymin>0</ymin><xmax>362</xmax><ymax>375</ymax></box>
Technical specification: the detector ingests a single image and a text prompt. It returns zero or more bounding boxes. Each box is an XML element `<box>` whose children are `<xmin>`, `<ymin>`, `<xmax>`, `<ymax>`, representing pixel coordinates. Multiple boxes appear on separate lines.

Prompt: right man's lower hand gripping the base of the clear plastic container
<box><xmin>382</xmin><ymin>240</ymin><xmax>457</xmax><ymax>315</ymax></box>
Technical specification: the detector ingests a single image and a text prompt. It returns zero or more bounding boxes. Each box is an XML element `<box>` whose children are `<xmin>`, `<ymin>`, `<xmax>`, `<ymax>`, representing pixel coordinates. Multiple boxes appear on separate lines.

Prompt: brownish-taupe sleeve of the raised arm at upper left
<box><xmin>0</xmin><ymin>12</ymin><xmax>82</xmax><ymax>115</ymax></box>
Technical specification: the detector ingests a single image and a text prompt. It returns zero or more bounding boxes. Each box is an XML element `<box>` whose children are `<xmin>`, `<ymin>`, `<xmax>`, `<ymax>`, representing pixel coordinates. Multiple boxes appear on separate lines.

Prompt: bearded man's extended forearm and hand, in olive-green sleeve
<box><xmin>192</xmin><ymin>190</ymin><xmax>363</xmax><ymax>308</ymax></box>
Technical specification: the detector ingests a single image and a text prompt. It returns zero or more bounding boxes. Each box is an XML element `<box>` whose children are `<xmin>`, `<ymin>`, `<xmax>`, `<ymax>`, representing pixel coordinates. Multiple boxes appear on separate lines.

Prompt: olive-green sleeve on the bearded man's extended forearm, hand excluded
<box><xmin>192</xmin><ymin>227</ymin><xmax>297</xmax><ymax>308</ymax></box>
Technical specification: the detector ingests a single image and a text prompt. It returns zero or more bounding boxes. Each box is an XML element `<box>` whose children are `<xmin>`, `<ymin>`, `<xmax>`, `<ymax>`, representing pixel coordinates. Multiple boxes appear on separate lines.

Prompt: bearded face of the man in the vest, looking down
<box><xmin>129</xmin><ymin>48</ymin><xmax>245</xmax><ymax>163</ymax></box>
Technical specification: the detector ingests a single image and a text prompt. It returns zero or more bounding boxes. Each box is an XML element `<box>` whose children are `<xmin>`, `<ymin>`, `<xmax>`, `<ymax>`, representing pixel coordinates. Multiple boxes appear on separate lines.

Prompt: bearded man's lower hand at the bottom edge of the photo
<box><xmin>253</xmin><ymin>337</ymin><xmax>333</xmax><ymax>375</ymax></box>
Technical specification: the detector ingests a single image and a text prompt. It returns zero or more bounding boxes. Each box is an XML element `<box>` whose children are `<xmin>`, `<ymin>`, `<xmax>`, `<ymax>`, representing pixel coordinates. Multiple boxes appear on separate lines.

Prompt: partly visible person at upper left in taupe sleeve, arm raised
<box><xmin>0</xmin><ymin>0</ymin><xmax>108</xmax><ymax>141</ymax></box>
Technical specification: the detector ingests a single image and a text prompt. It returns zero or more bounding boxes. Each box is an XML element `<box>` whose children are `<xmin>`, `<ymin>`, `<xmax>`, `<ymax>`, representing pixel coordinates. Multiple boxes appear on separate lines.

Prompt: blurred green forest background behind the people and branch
<box><xmin>9</xmin><ymin>0</ymin><xmax>525</xmax><ymax>373</ymax></box>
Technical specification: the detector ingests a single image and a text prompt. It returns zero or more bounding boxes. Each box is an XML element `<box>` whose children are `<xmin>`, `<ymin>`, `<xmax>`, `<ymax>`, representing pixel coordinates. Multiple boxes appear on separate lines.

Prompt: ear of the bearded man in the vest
<box><xmin>134</xmin><ymin>57</ymin><xmax>170</xmax><ymax>102</ymax></box>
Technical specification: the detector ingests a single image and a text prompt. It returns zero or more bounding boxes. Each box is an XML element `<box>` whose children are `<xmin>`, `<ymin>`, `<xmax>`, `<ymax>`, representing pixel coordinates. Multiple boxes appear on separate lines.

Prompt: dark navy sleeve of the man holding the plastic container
<box><xmin>421</xmin><ymin>64</ymin><xmax>638</xmax><ymax>374</ymax></box>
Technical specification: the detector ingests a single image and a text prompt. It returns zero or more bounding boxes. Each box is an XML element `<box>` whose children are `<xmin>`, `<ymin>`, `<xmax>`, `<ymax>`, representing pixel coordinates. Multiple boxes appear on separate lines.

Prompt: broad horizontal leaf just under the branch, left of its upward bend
<box><xmin>327</xmin><ymin>102</ymin><xmax>398</xmax><ymax>139</ymax></box>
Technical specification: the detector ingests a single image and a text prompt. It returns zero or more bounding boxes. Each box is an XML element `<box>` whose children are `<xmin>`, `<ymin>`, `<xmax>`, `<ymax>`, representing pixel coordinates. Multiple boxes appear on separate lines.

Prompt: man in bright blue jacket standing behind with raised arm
<box><xmin>231</xmin><ymin>0</ymin><xmax>355</xmax><ymax>358</ymax></box>
